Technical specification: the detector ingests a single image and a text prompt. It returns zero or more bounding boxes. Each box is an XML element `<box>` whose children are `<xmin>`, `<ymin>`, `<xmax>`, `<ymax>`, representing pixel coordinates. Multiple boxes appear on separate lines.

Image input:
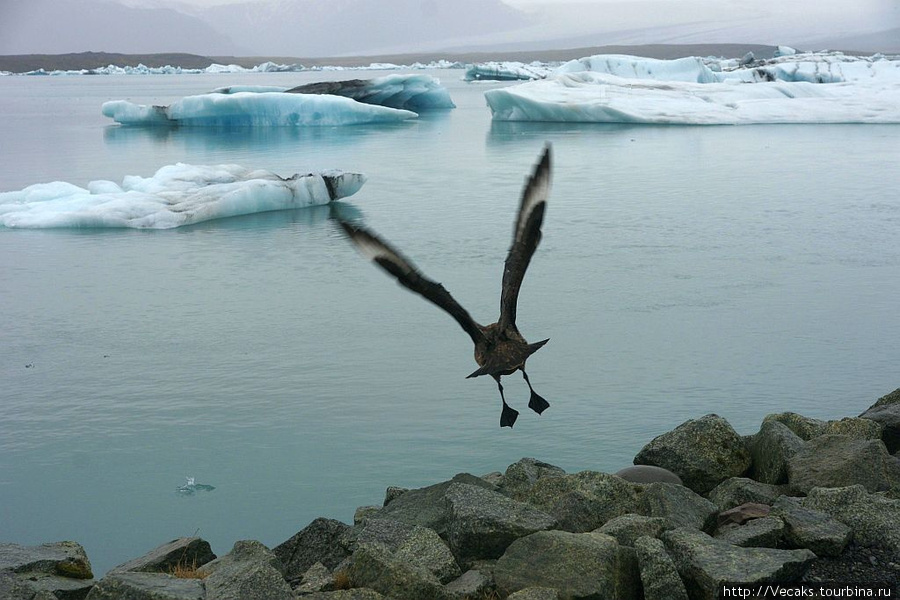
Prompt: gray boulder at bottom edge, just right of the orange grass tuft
<box><xmin>197</xmin><ymin>540</ymin><xmax>294</xmax><ymax>600</ymax></box>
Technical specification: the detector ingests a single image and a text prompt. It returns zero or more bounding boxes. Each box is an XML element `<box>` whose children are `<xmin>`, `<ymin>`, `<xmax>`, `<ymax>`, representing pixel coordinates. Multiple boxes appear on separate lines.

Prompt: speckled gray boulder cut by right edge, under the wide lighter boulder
<box><xmin>802</xmin><ymin>485</ymin><xmax>900</xmax><ymax>552</ymax></box>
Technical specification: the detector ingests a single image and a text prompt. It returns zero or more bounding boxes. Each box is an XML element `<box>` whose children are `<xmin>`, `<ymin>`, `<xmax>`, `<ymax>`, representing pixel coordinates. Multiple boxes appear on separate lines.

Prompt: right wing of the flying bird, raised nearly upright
<box><xmin>499</xmin><ymin>144</ymin><xmax>550</xmax><ymax>330</ymax></box>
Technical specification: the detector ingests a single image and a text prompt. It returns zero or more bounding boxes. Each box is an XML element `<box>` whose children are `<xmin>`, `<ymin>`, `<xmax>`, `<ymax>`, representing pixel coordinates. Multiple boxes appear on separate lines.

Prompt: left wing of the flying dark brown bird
<box><xmin>338</xmin><ymin>220</ymin><xmax>484</xmax><ymax>344</ymax></box>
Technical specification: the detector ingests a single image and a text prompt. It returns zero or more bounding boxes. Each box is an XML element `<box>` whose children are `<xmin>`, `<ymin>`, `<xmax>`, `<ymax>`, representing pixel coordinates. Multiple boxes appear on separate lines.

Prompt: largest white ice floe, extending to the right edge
<box><xmin>485</xmin><ymin>54</ymin><xmax>900</xmax><ymax>125</ymax></box>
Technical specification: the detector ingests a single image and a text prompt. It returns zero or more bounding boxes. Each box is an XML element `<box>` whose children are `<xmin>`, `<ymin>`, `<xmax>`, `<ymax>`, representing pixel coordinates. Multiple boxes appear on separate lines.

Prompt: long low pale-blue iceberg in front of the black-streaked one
<box><xmin>101</xmin><ymin>92</ymin><xmax>418</xmax><ymax>127</ymax></box>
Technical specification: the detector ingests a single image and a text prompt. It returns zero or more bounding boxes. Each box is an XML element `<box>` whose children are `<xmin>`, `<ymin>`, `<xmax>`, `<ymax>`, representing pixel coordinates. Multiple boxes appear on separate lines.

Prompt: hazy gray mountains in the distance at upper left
<box><xmin>0</xmin><ymin>0</ymin><xmax>528</xmax><ymax>56</ymax></box>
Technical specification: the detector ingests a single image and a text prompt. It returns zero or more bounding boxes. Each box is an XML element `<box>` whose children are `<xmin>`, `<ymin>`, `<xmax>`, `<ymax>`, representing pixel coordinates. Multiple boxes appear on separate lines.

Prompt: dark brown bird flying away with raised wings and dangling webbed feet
<box><xmin>339</xmin><ymin>144</ymin><xmax>550</xmax><ymax>427</ymax></box>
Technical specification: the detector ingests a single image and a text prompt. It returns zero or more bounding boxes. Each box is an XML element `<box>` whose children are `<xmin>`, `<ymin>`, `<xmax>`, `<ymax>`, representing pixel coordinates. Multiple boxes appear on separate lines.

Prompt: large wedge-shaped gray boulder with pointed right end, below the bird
<box><xmin>444</xmin><ymin>483</ymin><xmax>556</xmax><ymax>566</ymax></box>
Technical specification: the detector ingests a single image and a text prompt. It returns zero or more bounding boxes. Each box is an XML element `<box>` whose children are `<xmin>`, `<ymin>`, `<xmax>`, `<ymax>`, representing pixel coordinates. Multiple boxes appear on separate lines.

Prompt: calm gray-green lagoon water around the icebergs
<box><xmin>0</xmin><ymin>70</ymin><xmax>900</xmax><ymax>573</ymax></box>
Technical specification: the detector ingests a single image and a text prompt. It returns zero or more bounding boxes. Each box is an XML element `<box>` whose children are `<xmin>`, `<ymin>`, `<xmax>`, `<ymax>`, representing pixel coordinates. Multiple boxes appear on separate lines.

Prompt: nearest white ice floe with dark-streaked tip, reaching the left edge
<box><xmin>0</xmin><ymin>163</ymin><xmax>366</xmax><ymax>229</ymax></box>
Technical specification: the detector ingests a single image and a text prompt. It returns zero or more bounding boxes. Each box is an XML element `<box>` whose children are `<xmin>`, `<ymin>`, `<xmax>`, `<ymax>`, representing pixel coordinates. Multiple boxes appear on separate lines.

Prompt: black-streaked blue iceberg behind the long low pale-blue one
<box><xmin>287</xmin><ymin>75</ymin><xmax>456</xmax><ymax>111</ymax></box>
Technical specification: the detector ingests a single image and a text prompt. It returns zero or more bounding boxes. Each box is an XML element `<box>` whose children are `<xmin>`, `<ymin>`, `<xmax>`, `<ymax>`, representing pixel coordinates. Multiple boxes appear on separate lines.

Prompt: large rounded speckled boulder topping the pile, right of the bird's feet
<box><xmin>634</xmin><ymin>415</ymin><xmax>750</xmax><ymax>494</ymax></box>
